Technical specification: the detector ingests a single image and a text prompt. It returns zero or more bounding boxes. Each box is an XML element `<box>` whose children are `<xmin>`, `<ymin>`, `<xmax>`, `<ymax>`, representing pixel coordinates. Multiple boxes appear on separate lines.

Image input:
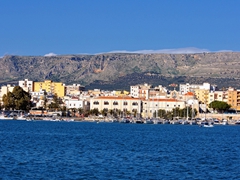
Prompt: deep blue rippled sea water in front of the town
<box><xmin>0</xmin><ymin>120</ymin><xmax>240</xmax><ymax>179</ymax></box>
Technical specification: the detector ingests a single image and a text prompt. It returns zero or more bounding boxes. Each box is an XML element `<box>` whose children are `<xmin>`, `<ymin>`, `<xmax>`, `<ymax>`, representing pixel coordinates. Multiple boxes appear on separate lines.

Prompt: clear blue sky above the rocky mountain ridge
<box><xmin>0</xmin><ymin>0</ymin><xmax>240</xmax><ymax>56</ymax></box>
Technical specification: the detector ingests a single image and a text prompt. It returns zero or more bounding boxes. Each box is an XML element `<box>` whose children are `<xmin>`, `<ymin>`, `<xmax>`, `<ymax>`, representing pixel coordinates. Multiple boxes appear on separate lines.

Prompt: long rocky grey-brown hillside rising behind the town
<box><xmin>0</xmin><ymin>52</ymin><xmax>240</xmax><ymax>89</ymax></box>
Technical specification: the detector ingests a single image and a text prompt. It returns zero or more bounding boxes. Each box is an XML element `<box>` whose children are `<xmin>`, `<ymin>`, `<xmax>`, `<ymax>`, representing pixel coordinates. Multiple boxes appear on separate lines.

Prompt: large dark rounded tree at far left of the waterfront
<box><xmin>3</xmin><ymin>86</ymin><xmax>31</xmax><ymax>110</ymax></box>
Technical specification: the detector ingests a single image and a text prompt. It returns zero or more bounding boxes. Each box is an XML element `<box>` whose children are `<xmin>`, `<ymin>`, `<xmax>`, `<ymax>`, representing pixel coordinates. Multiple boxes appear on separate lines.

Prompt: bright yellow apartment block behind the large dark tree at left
<box><xmin>33</xmin><ymin>80</ymin><xmax>65</xmax><ymax>97</ymax></box>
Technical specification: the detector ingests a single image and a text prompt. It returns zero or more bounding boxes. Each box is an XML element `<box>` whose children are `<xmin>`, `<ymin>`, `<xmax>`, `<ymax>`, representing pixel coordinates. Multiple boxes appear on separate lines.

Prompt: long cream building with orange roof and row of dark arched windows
<box><xmin>90</xmin><ymin>96</ymin><xmax>141</xmax><ymax>114</ymax></box>
